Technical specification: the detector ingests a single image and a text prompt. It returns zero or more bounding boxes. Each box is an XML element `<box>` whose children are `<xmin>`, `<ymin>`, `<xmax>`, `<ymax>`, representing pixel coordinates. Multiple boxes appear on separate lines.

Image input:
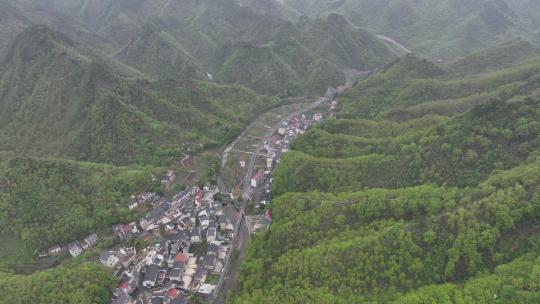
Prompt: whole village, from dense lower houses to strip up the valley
<box><xmin>35</xmin><ymin>100</ymin><xmax>336</xmax><ymax>304</ymax></box>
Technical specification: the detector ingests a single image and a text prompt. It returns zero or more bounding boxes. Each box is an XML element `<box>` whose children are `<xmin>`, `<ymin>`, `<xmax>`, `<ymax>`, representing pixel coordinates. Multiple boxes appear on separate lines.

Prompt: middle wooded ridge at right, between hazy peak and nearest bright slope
<box><xmin>273</xmin><ymin>99</ymin><xmax>540</xmax><ymax>195</ymax></box>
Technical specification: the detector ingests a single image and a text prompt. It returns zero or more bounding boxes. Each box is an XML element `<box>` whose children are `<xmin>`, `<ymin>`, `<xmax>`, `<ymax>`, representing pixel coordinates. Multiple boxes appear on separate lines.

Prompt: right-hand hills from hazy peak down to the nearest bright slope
<box><xmin>274</xmin><ymin>56</ymin><xmax>540</xmax><ymax>195</ymax></box>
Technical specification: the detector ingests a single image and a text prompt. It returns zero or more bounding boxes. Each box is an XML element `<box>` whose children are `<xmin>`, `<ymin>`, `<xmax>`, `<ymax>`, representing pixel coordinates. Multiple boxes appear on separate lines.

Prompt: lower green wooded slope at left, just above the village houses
<box><xmin>0</xmin><ymin>158</ymin><xmax>159</xmax><ymax>262</ymax></box>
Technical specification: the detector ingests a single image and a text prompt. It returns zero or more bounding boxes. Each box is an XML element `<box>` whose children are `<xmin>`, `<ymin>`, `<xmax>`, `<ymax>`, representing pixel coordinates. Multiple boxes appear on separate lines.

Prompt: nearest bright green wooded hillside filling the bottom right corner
<box><xmin>230</xmin><ymin>159</ymin><xmax>540</xmax><ymax>303</ymax></box>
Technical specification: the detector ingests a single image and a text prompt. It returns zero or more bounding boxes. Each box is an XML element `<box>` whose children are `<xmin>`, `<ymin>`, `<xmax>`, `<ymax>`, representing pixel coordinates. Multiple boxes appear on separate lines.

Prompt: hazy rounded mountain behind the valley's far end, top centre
<box><xmin>215</xmin><ymin>15</ymin><xmax>395</xmax><ymax>96</ymax></box>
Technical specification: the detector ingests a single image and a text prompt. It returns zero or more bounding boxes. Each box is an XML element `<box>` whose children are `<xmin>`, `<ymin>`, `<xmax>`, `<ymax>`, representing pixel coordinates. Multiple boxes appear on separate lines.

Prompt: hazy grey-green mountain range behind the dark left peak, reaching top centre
<box><xmin>4</xmin><ymin>0</ymin><xmax>395</xmax><ymax>96</ymax></box>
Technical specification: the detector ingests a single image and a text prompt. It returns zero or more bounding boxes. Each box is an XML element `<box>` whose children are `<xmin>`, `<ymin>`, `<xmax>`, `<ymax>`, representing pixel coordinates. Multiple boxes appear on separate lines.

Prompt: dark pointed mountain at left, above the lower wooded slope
<box><xmin>0</xmin><ymin>26</ymin><xmax>276</xmax><ymax>164</ymax></box>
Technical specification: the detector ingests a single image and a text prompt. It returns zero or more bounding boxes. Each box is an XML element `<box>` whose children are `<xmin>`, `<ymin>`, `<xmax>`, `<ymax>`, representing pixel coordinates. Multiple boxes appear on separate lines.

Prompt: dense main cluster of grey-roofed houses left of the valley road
<box><xmin>105</xmin><ymin>187</ymin><xmax>241</xmax><ymax>304</ymax></box>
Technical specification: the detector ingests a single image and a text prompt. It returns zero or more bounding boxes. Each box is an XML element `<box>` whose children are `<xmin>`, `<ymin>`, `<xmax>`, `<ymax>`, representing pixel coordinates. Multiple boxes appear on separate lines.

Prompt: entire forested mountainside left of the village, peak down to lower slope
<box><xmin>0</xmin><ymin>25</ymin><xmax>279</xmax><ymax>272</ymax></box>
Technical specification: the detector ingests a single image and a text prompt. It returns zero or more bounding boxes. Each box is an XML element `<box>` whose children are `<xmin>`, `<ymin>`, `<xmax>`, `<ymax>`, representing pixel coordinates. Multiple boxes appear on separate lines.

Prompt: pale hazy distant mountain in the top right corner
<box><xmin>284</xmin><ymin>0</ymin><xmax>539</xmax><ymax>60</ymax></box>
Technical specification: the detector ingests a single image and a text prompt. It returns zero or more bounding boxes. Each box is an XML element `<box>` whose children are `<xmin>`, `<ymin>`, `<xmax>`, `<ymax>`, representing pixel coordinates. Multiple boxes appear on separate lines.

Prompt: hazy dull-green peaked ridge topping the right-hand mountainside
<box><xmin>338</xmin><ymin>55</ymin><xmax>540</xmax><ymax>120</ymax></box>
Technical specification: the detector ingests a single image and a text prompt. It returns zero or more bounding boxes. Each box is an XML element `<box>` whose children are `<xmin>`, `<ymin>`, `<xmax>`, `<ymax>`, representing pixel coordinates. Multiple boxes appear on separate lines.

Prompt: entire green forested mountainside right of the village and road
<box><xmin>228</xmin><ymin>50</ymin><xmax>540</xmax><ymax>304</ymax></box>
